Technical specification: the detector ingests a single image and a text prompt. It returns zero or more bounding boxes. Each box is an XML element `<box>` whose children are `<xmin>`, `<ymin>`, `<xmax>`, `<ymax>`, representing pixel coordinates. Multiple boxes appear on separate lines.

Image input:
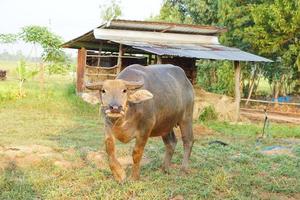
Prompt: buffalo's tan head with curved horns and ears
<box><xmin>86</xmin><ymin>79</ymin><xmax>153</xmax><ymax>118</ymax></box>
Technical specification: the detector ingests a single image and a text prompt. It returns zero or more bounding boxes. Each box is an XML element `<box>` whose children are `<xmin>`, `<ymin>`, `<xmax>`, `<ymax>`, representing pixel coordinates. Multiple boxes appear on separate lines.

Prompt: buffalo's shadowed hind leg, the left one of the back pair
<box><xmin>162</xmin><ymin>130</ymin><xmax>177</xmax><ymax>172</ymax></box>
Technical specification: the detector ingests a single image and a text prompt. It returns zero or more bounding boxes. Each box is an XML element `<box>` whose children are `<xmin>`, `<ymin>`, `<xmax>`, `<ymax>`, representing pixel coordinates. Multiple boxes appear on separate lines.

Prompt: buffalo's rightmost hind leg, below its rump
<box><xmin>179</xmin><ymin>120</ymin><xmax>194</xmax><ymax>172</ymax></box>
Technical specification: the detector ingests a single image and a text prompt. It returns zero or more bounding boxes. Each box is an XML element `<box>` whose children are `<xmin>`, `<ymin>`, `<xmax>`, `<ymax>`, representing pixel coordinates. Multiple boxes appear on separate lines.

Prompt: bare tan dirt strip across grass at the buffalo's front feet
<box><xmin>0</xmin><ymin>145</ymin><xmax>150</xmax><ymax>169</ymax></box>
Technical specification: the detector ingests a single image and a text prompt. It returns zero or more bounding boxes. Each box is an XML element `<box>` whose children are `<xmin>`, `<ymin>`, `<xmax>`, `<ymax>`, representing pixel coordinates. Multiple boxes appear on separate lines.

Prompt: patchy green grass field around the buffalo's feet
<box><xmin>0</xmin><ymin>63</ymin><xmax>300</xmax><ymax>200</ymax></box>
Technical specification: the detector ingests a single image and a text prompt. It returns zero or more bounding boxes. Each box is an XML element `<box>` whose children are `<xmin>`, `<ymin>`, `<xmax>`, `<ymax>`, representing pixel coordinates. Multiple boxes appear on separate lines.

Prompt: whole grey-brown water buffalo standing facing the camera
<box><xmin>86</xmin><ymin>65</ymin><xmax>194</xmax><ymax>182</ymax></box>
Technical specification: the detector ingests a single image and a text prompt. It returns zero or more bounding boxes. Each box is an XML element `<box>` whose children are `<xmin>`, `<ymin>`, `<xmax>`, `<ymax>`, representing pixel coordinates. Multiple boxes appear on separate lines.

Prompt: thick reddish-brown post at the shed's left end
<box><xmin>76</xmin><ymin>47</ymin><xmax>86</xmax><ymax>94</ymax></box>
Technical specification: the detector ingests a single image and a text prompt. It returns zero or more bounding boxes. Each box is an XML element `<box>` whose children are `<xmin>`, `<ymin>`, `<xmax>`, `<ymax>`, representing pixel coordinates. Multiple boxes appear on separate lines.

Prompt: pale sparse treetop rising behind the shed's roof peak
<box><xmin>100</xmin><ymin>0</ymin><xmax>122</xmax><ymax>22</ymax></box>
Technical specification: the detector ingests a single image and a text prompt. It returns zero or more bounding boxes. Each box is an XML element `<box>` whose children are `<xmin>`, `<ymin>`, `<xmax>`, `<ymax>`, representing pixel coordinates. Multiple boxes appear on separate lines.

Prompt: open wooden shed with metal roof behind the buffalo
<box><xmin>63</xmin><ymin>20</ymin><xmax>272</xmax><ymax>119</ymax></box>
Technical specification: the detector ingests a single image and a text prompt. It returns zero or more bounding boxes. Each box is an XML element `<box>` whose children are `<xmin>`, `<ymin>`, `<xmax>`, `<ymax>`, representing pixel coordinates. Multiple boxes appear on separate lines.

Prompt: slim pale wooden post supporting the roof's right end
<box><xmin>234</xmin><ymin>61</ymin><xmax>241</xmax><ymax>122</ymax></box>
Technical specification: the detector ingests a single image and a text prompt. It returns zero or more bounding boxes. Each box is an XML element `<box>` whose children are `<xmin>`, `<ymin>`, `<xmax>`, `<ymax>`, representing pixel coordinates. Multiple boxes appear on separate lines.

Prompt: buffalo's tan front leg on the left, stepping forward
<box><xmin>105</xmin><ymin>135</ymin><xmax>126</xmax><ymax>183</ymax></box>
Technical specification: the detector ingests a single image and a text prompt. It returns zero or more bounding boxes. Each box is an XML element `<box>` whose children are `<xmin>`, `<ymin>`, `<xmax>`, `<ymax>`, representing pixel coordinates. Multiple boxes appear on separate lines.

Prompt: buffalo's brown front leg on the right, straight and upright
<box><xmin>131</xmin><ymin>137</ymin><xmax>148</xmax><ymax>180</ymax></box>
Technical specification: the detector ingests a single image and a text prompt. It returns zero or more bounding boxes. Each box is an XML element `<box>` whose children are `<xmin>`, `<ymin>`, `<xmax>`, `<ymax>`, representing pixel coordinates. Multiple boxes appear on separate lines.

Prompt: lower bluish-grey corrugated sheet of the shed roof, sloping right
<box><xmin>114</xmin><ymin>41</ymin><xmax>273</xmax><ymax>62</ymax></box>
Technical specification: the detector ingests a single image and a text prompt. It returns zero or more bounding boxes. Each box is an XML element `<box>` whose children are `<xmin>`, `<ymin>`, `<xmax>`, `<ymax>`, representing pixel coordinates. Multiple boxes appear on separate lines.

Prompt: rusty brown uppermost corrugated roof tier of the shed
<box><xmin>106</xmin><ymin>20</ymin><xmax>226</xmax><ymax>35</ymax></box>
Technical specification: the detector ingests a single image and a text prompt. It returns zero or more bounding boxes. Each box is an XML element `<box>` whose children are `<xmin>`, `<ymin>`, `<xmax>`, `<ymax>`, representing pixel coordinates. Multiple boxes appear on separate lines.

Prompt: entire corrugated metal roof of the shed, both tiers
<box><xmin>63</xmin><ymin>20</ymin><xmax>272</xmax><ymax>62</ymax></box>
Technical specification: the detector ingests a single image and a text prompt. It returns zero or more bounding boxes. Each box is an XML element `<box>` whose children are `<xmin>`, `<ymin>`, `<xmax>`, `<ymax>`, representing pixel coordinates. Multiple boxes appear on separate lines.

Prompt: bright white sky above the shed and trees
<box><xmin>0</xmin><ymin>0</ymin><xmax>163</xmax><ymax>55</ymax></box>
